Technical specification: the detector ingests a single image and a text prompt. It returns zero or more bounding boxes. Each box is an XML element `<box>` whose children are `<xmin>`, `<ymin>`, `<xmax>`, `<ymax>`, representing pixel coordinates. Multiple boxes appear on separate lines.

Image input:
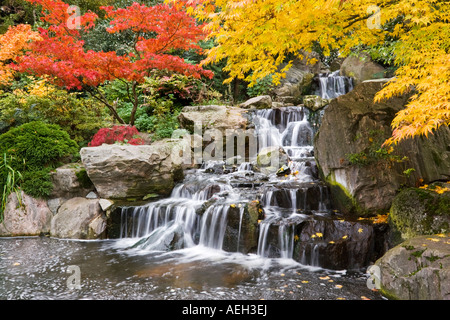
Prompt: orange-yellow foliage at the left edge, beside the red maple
<box><xmin>0</xmin><ymin>24</ymin><xmax>40</xmax><ymax>85</ymax></box>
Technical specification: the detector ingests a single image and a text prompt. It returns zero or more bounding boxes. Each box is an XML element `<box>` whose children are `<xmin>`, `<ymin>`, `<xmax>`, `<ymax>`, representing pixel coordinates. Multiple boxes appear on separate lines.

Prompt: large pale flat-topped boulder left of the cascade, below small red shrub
<box><xmin>80</xmin><ymin>140</ymin><xmax>183</xmax><ymax>200</ymax></box>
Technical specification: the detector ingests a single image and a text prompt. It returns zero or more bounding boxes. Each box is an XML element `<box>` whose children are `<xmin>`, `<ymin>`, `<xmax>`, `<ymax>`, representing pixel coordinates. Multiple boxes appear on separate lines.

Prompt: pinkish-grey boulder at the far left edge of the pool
<box><xmin>0</xmin><ymin>192</ymin><xmax>53</xmax><ymax>237</ymax></box>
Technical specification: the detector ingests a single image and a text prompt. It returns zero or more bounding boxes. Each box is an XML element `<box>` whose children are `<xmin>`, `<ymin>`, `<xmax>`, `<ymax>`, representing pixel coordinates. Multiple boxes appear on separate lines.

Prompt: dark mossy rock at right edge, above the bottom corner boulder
<box><xmin>390</xmin><ymin>184</ymin><xmax>450</xmax><ymax>245</ymax></box>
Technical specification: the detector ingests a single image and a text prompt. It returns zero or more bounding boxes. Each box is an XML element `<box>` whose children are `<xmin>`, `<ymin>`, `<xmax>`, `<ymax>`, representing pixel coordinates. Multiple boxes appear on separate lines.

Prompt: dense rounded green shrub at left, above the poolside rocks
<box><xmin>0</xmin><ymin>121</ymin><xmax>79</xmax><ymax>198</ymax></box>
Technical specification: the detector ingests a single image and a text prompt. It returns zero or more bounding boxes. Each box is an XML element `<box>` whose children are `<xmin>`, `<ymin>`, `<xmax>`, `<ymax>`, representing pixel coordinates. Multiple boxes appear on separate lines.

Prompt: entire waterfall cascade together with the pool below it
<box><xmin>0</xmin><ymin>70</ymin><xmax>381</xmax><ymax>300</ymax></box>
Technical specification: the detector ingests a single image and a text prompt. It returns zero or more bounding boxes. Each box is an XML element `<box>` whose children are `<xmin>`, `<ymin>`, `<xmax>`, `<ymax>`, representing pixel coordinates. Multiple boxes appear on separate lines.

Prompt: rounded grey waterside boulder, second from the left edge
<box><xmin>50</xmin><ymin>197</ymin><xmax>107</xmax><ymax>239</ymax></box>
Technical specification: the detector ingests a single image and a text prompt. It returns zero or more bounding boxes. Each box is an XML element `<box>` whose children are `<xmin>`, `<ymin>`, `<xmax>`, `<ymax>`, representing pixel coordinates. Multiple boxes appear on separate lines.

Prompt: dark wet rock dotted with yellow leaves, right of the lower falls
<box><xmin>260</xmin><ymin>218</ymin><xmax>387</xmax><ymax>270</ymax></box>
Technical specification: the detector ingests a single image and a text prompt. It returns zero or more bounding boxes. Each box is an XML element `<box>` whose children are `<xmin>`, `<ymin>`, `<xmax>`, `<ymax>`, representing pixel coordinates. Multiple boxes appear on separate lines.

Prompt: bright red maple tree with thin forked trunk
<box><xmin>14</xmin><ymin>0</ymin><xmax>213</xmax><ymax>125</ymax></box>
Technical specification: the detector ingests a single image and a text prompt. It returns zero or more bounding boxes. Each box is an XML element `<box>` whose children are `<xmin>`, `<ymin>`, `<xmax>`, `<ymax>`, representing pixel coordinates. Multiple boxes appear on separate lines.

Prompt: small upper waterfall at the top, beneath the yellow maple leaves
<box><xmin>319</xmin><ymin>70</ymin><xmax>353</xmax><ymax>99</ymax></box>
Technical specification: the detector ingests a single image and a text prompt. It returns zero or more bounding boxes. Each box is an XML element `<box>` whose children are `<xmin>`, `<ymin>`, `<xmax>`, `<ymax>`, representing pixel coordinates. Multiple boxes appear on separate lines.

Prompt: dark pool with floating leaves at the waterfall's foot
<box><xmin>0</xmin><ymin>237</ymin><xmax>382</xmax><ymax>300</ymax></box>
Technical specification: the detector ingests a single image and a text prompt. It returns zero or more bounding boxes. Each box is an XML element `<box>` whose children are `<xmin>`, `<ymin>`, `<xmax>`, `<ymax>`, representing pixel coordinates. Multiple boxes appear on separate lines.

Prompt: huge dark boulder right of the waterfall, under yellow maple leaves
<box><xmin>314</xmin><ymin>80</ymin><xmax>450</xmax><ymax>215</ymax></box>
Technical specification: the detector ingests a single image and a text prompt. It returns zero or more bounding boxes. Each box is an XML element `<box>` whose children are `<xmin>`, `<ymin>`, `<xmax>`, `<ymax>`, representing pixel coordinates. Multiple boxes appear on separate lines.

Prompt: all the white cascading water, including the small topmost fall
<box><xmin>121</xmin><ymin>72</ymin><xmax>351</xmax><ymax>262</ymax></box>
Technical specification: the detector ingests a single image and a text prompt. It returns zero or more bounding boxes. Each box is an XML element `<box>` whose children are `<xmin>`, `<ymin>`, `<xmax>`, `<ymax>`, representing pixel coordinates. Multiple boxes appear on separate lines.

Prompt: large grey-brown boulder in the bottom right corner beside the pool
<box><xmin>375</xmin><ymin>234</ymin><xmax>450</xmax><ymax>300</ymax></box>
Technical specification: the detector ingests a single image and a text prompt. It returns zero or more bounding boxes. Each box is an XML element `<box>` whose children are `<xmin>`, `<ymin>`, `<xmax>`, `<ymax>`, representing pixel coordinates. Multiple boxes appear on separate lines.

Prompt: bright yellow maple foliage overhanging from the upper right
<box><xmin>184</xmin><ymin>0</ymin><xmax>450</xmax><ymax>143</ymax></box>
